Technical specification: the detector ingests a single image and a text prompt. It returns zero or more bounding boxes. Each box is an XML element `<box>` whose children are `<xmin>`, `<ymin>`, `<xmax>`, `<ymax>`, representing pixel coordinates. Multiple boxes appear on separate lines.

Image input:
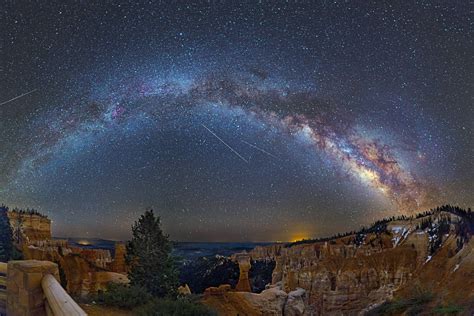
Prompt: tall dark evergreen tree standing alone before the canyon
<box><xmin>125</xmin><ymin>210</ymin><xmax>179</xmax><ymax>297</ymax></box>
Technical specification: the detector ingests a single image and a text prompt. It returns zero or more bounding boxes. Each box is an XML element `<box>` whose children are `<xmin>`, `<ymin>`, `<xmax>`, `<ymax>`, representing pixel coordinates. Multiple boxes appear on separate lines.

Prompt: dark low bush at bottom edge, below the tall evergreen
<box><xmin>134</xmin><ymin>298</ymin><xmax>217</xmax><ymax>316</ymax></box>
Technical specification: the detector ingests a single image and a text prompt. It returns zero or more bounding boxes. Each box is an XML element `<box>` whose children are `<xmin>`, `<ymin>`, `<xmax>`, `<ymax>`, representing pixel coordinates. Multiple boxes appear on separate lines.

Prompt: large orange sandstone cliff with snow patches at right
<box><xmin>204</xmin><ymin>212</ymin><xmax>474</xmax><ymax>315</ymax></box>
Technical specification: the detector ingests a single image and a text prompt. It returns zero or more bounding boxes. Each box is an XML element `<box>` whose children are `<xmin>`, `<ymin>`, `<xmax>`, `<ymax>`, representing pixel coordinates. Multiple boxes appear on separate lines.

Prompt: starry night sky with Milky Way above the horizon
<box><xmin>0</xmin><ymin>1</ymin><xmax>474</xmax><ymax>241</ymax></box>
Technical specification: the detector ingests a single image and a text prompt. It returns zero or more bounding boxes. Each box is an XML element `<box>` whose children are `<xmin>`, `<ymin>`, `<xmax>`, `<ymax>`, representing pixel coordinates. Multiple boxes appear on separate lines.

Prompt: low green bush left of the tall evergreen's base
<box><xmin>97</xmin><ymin>283</ymin><xmax>152</xmax><ymax>309</ymax></box>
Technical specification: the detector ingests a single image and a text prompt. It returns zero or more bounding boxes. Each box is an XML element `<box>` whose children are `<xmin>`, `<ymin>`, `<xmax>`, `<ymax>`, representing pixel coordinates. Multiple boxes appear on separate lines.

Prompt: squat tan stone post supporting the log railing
<box><xmin>7</xmin><ymin>260</ymin><xmax>59</xmax><ymax>316</ymax></box>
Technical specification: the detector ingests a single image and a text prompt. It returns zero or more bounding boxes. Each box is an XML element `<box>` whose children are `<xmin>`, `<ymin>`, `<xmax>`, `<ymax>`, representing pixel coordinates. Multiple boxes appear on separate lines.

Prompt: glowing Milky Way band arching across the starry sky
<box><xmin>7</xmin><ymin>73</ymin><xmax>434</xmax><ymax>211</ymax></box>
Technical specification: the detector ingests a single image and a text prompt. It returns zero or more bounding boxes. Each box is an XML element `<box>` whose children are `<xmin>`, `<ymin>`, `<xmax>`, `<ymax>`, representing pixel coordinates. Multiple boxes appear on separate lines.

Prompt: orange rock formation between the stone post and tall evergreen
<box><xmin>8</xmin><ymin>211</ymin><xmax>128</xmax><ymax>296</ymax></box>
